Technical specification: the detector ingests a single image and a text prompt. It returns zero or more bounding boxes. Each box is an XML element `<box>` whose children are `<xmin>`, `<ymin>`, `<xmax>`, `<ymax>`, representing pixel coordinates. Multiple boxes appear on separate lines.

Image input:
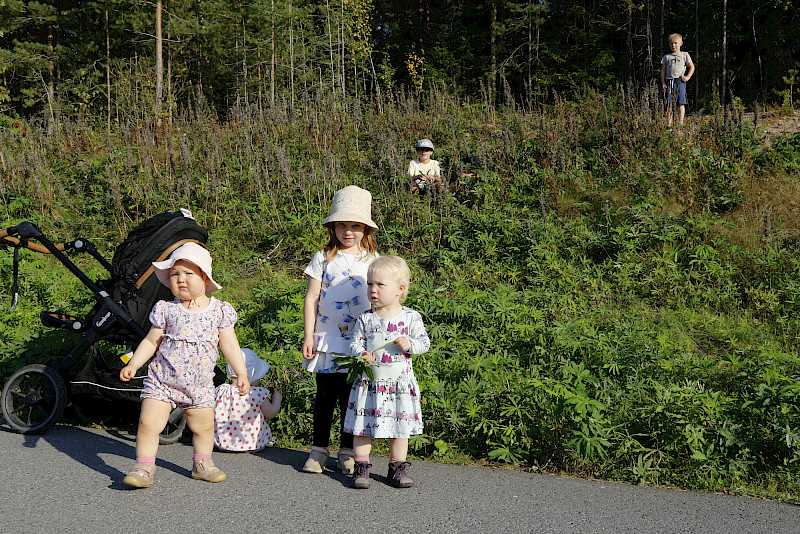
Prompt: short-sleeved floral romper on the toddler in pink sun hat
<box><xmin>141</xmin><ymin>297</ymin><xmax>237</xmax><ymax>408</ymax></box>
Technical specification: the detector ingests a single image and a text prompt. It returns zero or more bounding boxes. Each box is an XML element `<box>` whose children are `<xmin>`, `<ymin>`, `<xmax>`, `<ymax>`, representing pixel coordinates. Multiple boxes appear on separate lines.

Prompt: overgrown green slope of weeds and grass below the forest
<box><xmin>0</xmin><ymin>86</ymin><xmax>800</xmax><ymax>500</ymax></box>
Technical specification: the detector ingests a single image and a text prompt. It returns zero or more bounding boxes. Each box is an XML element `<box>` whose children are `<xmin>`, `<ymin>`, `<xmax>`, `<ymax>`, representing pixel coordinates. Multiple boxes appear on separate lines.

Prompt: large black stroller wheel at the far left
<box><xmin>2</xmin><ymin>364</ymin><xmax>67</xmax><ymax>434</ymax></box>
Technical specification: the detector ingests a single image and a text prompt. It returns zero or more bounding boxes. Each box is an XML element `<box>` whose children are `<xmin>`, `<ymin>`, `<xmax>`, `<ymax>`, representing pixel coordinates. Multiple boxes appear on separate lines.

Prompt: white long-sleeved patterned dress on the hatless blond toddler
<box><xmin>344</xmin><ymin>306</ymin><xmax>431</xmax><ymax>438</ymax></box>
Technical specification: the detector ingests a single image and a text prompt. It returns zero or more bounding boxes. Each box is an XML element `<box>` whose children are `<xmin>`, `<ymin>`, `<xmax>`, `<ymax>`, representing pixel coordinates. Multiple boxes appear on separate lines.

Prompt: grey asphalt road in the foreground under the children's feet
<box><xmin>0</xmin><ymin>424</ymin><xmax>800</xmax><ymax>534</ymax></box>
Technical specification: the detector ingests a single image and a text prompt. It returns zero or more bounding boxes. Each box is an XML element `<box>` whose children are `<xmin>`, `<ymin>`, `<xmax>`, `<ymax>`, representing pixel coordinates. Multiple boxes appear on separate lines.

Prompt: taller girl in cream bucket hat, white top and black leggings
<box><xmin>303</xmin><ymin>185</ymin><xmax>378</xmax><ymax>475</ymax></box>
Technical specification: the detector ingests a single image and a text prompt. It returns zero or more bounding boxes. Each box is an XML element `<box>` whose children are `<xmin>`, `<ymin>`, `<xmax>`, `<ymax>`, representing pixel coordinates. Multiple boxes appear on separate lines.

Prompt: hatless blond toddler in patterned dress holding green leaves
<box><xmin>344</xmin><ymin>256</ymin><xmax>431</xmax><ymax>489</ymax></box>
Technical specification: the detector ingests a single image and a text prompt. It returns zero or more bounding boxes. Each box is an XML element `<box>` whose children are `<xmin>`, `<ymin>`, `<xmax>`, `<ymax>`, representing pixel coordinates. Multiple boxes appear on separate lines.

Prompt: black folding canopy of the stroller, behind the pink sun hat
<box><xmin>106</xmin><ymin>211</ymin><xmax>208</xmax><ymax>332</ymax></box>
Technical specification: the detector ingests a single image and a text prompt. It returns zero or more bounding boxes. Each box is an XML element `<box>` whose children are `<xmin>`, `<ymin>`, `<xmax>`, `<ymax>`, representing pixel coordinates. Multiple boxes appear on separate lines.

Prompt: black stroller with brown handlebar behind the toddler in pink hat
<box><xmin>0</xmin><ymin>210</ymin><xmax>216</xmax><ymax>444</ymax></box>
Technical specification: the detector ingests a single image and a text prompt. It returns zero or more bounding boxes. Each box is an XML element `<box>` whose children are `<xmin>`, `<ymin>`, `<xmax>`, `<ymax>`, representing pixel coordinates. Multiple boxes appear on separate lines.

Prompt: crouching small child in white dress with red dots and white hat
<box><xmin>214</xmin><ymin>349</ymin><xmax>283</xmax><ymax>452</ymax></box>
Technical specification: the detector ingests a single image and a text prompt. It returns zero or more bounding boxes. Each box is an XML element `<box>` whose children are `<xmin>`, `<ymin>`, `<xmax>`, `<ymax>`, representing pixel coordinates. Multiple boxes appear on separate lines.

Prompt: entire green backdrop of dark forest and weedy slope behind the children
<box><xmin>0</xmin><ymin>0</ymin><xmax>800</xmax><ymax>502</ymax></box>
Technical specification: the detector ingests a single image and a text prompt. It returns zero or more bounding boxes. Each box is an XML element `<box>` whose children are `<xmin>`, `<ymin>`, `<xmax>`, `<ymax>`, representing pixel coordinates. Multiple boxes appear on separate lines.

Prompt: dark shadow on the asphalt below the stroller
<box><xmin>0</xmin><ymin>423</ymin><xmax>186</xmax><ymax>491</ymax></box>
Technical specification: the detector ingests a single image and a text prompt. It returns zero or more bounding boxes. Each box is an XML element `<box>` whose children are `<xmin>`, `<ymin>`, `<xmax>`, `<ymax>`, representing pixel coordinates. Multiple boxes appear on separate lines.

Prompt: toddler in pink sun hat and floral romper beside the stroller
<box><xmin>119</xmin><ymin>243</ymin><xmax>250</xmax><ymax>488</ymax></box>
